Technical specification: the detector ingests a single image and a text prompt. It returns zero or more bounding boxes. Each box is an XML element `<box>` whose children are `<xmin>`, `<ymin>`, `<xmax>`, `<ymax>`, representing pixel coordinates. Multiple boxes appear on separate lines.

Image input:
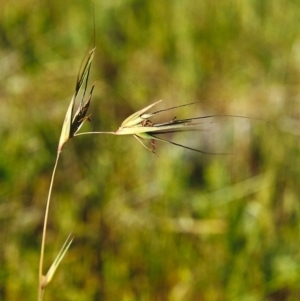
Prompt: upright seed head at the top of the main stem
<box><xmin>58</xmin><ymin>48</ymin><xmax>95</xmax><ymax>152</ymax></box>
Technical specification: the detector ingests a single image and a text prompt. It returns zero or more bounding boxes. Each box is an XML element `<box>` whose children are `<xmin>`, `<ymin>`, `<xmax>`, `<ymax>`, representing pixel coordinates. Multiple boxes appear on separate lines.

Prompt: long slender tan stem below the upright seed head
<box><xmin>38</xmin><ymin>152</ymin><xmax>60</xmax><ymax>301</ymax></box>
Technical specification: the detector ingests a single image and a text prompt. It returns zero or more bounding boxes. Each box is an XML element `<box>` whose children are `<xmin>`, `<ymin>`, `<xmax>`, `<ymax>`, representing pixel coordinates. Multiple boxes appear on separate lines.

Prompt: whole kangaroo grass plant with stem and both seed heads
<box><xmin>38</xmin><ymin>48</ymin><xmax>255</xmax><ymax>301</ymax></box>
